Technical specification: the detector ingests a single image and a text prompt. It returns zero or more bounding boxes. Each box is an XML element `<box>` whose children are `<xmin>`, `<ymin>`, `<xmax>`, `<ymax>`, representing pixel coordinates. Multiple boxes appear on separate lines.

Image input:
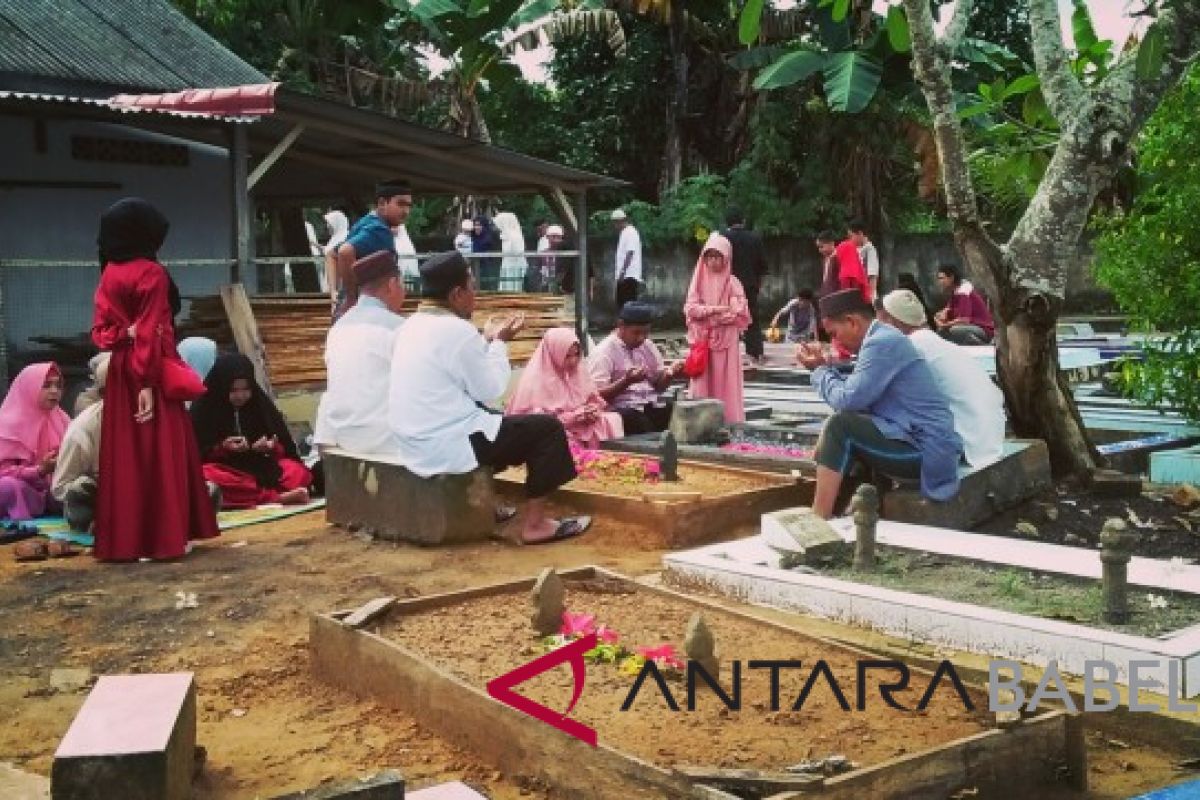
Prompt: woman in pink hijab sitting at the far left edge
<box><xmin>0</xmin><ymin>361</ymin><xmax>71</xmax><ymax>519</ymax></box>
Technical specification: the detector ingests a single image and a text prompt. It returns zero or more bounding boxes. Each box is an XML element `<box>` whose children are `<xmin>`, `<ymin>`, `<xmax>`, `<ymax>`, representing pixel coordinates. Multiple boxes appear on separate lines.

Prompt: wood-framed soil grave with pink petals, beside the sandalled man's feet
<box><xmin>496</xmin><ymin>455</ymin><xmax>812</xmax><ymax>549</ymax></box>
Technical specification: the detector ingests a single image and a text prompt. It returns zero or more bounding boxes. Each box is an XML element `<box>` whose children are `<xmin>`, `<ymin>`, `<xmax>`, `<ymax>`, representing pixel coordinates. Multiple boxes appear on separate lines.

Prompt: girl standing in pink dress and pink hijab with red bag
<box><xmin>683</xmin><ymin>234</ymin><xmax>750</xmax><ymax>422</ymax></box>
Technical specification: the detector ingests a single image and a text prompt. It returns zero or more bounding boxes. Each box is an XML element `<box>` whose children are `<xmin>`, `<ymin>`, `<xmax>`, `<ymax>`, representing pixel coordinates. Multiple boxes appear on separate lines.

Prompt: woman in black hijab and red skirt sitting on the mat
<box><xmin>192</xmin><ymin>354</ymin><xmax>312</xmax><ymax>509</ymax></box>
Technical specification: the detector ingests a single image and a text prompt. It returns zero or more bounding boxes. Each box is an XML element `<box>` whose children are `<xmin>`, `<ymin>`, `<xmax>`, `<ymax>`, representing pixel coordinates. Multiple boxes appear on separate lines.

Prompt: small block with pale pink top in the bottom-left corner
<box><xmin>50</xmin><ymin>673</ymin><xmax>196</xmax><ymax>800</ymax></box>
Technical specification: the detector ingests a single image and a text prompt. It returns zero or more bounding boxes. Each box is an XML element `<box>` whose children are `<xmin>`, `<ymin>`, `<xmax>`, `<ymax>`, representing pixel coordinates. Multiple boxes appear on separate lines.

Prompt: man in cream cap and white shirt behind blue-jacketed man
<box><xmin>876</xmin><ymin>289</ymin><xmax>1004</xmax><ymax>468</ymax></box>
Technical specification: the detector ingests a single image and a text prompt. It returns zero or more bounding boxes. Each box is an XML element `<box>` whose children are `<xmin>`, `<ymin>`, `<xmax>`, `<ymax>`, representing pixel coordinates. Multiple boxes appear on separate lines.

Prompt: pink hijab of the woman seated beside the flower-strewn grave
<box><xmin>506</xmin><ymin>327</ymin><xmax>605</xmax><ymax>414</ymax></box>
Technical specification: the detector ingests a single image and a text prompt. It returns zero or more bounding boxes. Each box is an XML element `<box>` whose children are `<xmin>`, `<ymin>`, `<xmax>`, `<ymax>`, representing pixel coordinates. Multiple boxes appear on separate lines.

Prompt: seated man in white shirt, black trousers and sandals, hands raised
<box><xmin>386</xmin><ymin>251</ymin><xmax>592</xmax><ymax>543</ymax></box>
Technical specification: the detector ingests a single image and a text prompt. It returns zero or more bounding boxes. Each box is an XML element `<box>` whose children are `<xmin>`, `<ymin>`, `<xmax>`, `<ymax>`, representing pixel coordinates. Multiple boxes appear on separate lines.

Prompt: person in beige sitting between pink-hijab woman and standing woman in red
<box><xmin>50</xmin><ymin>351</ymin><xmax>112</xmax><ymax>534</ymax></box>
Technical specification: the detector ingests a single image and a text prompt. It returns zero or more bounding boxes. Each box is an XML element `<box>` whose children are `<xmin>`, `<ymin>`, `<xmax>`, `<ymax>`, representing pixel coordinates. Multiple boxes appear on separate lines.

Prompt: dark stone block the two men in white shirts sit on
<box><xmin>323</xmin><ymin>449</ymin><xmax>496</xmax><ymax>545</ymax></box>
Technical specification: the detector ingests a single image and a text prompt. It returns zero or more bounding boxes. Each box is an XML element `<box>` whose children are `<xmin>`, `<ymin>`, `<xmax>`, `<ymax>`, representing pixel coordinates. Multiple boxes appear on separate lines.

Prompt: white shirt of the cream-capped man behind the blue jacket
<box><xmin>908</xmin><ymin>327</ymin><xmax>1006</xmax><ymax>468</ymax></box>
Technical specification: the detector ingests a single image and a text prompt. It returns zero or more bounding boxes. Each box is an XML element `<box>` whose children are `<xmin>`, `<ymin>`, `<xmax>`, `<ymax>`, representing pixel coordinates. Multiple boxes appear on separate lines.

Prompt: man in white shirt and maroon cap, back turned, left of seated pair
<box><xmin>313</xmin><ymin>251</ymin><xmax>404</xmax><ymax>456</ymax></box>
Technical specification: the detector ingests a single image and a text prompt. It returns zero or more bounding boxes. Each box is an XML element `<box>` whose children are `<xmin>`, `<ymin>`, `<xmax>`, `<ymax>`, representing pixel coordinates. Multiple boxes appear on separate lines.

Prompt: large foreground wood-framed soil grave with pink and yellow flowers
<box><xmin>310</xmin><ymin>567</ymin><xmax>1086</xmax><ymax>800</ymax></box>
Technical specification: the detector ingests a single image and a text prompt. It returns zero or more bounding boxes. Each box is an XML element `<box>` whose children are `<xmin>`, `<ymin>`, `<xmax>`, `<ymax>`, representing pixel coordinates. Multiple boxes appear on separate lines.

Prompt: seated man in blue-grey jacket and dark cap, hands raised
<box><xmin>797</xmin><ymin>288</ymin><xmax>962</xmax><ymax>519</ymax></box>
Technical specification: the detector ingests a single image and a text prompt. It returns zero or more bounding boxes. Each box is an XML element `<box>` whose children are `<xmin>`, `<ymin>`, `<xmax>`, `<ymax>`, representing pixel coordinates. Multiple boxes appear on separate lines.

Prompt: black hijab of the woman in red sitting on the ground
<box><xmin>192</xmin><ymin>353</ymin><xmax>300</xmax><ymax>488</ymax></box>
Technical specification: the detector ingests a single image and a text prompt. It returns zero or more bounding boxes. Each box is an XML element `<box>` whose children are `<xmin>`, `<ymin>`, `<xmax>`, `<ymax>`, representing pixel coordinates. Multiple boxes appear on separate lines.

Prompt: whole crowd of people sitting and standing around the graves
<box><xmin>0</xmin><ymin>181</ymin><xmax>1004</xmax><ymax>561</ymax></box>
